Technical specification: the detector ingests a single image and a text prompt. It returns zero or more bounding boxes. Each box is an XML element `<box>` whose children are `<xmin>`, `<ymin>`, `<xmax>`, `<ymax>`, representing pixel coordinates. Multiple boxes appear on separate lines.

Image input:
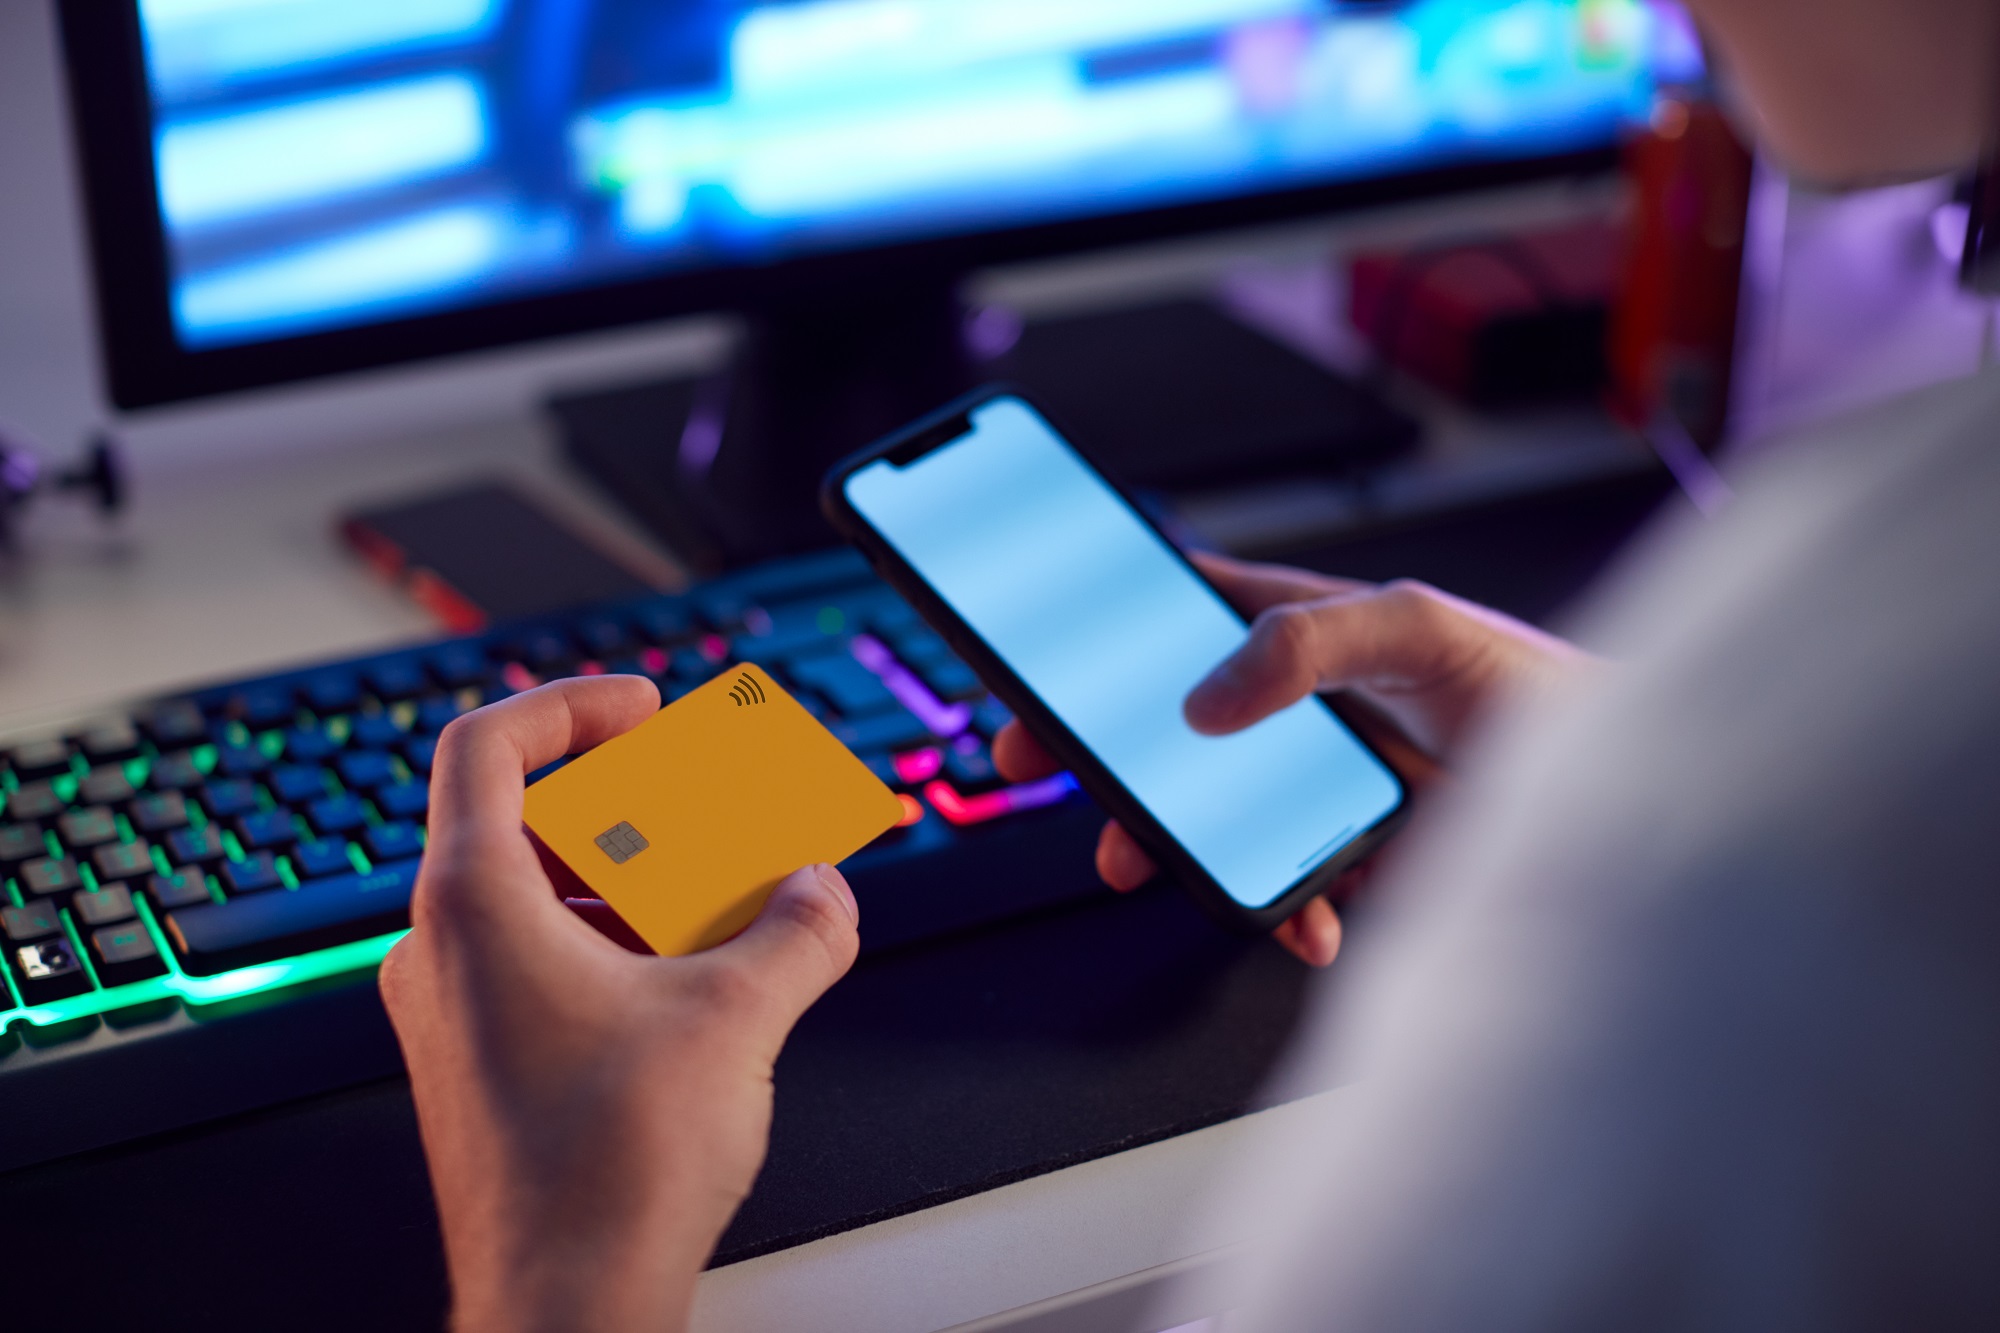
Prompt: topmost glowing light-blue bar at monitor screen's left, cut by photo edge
<box><xmin>140</xmin><ymin>0</ymin><xmax>500</xmax><ymax>96</ymax></box>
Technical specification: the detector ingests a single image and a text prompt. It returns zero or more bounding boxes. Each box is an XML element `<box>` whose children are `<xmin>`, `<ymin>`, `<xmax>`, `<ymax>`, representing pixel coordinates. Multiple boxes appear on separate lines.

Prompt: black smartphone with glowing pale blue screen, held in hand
<box><xmin>822</xmin><ymin>388</ymin><xmax>1408</xmax><ymax>929</ymax></box>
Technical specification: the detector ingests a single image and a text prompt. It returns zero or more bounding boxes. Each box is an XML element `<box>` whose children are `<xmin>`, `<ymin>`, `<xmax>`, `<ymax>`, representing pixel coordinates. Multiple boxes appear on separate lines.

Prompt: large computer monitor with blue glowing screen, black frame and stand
<box><xmin>58</xmin><ymin>0</ymin><xmax>1700</xmax><ymax>562</ymax></box>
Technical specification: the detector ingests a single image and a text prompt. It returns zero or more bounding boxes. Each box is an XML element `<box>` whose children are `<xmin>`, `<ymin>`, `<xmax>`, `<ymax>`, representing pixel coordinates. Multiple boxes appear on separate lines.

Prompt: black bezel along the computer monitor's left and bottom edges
<box><xmin>58</xmin><ymin>0</ymin><xmax>1618</xmax><ymax>410</ymax></box>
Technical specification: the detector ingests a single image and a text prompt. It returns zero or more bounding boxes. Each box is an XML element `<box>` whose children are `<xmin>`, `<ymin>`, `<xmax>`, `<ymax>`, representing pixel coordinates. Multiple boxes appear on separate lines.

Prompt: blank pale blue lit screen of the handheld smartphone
<box><xmin>848</xmin><ymin>398</ymin><xmax>1402</xmax><ymax>907</ymax></box>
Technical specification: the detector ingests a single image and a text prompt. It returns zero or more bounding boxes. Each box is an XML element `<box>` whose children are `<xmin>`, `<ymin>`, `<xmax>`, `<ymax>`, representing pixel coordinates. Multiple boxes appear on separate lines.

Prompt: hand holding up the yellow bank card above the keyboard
<box><xmin>382</xmin><ymin>677</ymin><xmax>858</xmax><ymax>1331</ymax></box>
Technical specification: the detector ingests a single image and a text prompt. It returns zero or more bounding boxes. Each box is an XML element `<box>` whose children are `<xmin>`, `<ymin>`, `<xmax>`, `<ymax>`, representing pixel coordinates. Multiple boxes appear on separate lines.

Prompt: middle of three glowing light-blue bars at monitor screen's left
<box><xmin>160</xmin><ymin>74</ymin><xmax>486</xmax><ymax>228</ymax></box>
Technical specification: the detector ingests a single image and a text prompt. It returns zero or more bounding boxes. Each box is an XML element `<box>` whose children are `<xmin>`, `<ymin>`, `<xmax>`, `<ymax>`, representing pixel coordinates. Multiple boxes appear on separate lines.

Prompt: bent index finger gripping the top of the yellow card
<box><xmin>430</xmin><ymin>677</ymin><xmax>660</xmax><ymax>843</ymax></box>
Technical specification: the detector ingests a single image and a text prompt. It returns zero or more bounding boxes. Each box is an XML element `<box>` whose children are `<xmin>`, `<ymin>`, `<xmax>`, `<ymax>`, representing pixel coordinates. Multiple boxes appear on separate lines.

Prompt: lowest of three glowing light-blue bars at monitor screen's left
<box><xmin>174</xmin><ymin>206</ymin><xmax>510</xmax><ymax>342</ymax></box>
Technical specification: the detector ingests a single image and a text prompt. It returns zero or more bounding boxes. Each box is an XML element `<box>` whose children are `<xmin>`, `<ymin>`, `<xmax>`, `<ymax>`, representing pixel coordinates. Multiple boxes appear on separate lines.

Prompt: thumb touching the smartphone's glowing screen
<box><xmin>1186</xmin><ymin>582</ymin><xmax>1466</xmax><ymax>735</ymax></box>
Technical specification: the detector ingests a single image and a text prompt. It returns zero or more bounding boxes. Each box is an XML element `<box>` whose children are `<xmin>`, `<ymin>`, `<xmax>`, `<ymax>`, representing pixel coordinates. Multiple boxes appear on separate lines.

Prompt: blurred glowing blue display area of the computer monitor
<box><xmin>138</xmin><ymin>0</ymin><xmax>1698</xmax><ymax>348</ymax></box>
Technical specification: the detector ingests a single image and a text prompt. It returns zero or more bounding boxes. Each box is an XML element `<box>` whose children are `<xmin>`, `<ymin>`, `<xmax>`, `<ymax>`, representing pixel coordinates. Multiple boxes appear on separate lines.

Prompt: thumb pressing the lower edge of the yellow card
<box><xmin>700</xmin><ymin>865</ymin><xmax>860</xmax><ymax>1047</ymax></box>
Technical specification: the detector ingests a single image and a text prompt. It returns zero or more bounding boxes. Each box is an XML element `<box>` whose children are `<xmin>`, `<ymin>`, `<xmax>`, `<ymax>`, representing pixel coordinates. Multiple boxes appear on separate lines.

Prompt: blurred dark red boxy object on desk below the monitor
<box><xmin>1348</xmin><ymin>220</ymin><xmax>1624</xmax><ymax>406</ymax></box>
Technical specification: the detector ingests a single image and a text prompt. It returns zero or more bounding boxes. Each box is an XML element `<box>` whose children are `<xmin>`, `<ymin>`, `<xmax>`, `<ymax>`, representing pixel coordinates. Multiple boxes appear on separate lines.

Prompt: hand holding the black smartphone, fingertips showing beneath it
<box><xmin>994</xmin><ymin>554</ymin><xmax>1596</xmax><ymax>967</ymax></box>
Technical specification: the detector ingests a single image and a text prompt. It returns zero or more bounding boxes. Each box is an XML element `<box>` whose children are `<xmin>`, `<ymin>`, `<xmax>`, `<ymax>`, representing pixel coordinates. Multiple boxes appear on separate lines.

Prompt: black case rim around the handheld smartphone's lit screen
<box><xmin>820</xmin><ymin>384</ymin><xmax>1410</xmax><ymax>931</ymax></box>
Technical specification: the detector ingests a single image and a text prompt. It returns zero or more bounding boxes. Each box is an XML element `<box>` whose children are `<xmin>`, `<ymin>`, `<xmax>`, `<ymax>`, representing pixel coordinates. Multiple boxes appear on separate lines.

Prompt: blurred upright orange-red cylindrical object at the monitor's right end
<box><xmin>1608</xmin><ymin>96</ymin><xmax>1752</xmax><ymax>448</ymax></box>
